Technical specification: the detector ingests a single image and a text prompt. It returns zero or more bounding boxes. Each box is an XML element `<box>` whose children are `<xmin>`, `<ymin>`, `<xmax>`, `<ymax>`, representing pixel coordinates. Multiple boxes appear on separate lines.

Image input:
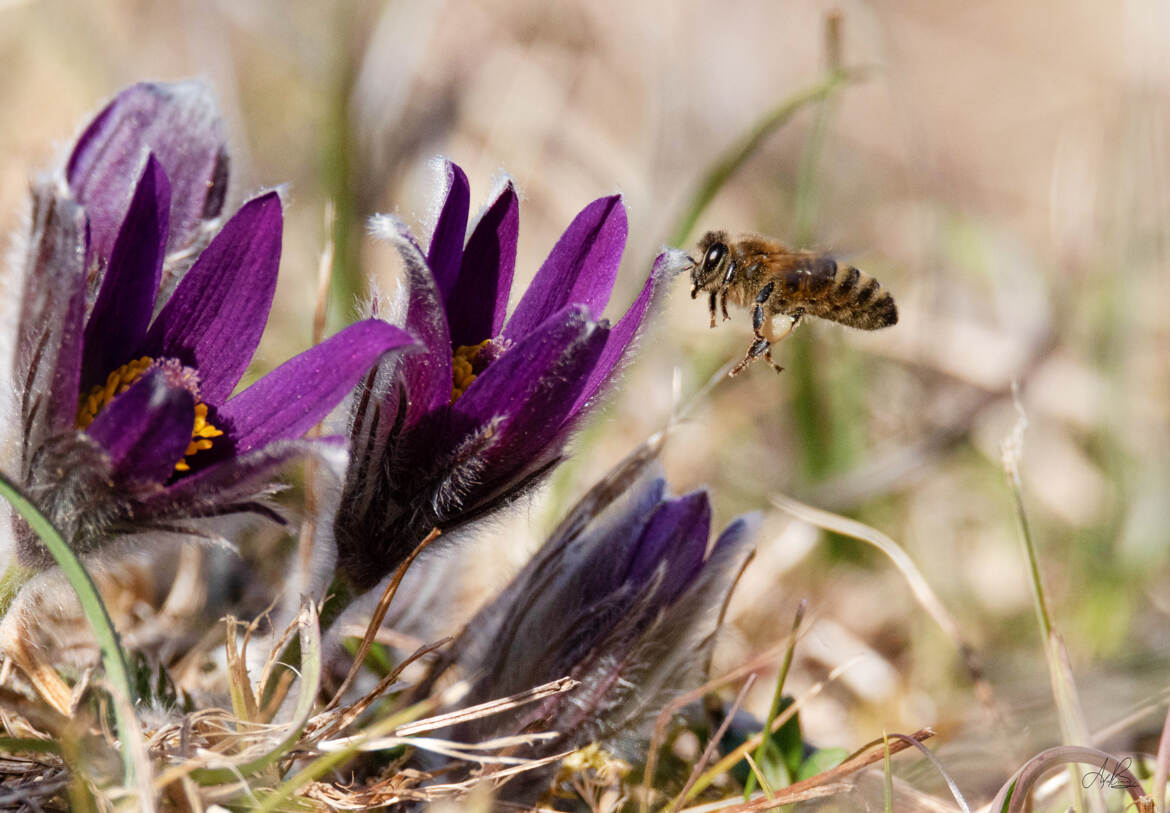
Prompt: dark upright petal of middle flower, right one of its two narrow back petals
<box><xmin>445</xmin><ymin>181</ymin><xmax>519</xmax><ymax>347</ymax></box>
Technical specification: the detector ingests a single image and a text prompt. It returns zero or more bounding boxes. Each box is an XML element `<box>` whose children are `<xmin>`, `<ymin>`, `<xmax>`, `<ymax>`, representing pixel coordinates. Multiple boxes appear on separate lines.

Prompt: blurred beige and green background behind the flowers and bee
<box><xmin>0</xmin><ymin>0</ymin><xmax>1170</xmax><ymax>800</ymax></box>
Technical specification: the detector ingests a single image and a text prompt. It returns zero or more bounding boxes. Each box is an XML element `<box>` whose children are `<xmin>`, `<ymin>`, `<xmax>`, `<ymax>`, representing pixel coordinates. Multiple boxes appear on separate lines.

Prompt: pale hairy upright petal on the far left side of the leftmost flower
<box><xmin>14</xmin><ymin>181</ymin><xmax>87</xmax><ymax>449</ymax></box>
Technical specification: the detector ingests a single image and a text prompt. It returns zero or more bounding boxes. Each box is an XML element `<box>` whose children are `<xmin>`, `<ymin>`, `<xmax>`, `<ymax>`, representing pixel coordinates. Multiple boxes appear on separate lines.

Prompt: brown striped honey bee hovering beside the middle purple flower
<box><xmin>690</xmin><ymin>232</ymin><xmax>897</xmax><ymax>376</ymax></box>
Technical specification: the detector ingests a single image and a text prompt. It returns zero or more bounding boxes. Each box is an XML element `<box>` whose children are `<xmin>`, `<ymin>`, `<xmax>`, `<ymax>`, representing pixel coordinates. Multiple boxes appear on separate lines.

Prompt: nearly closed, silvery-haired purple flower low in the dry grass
<box><xmin>437</xmin><ymin>447</ymin><xmax>751</xmax><ymax>802</ymax></box>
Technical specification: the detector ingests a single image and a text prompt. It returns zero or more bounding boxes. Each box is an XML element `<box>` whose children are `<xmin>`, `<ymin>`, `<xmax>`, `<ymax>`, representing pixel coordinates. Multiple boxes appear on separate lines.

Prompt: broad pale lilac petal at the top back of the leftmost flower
<box><xmin>66</xmin><ymin>82</ymin><xmax>227</xmax><ymax>264</ymax></box>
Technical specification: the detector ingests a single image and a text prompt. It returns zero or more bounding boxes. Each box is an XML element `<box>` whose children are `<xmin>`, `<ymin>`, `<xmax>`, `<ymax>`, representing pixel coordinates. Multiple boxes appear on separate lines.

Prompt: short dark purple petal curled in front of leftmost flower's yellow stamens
<box><xmin>85</xmin><ymin>370</ymin><xmax>195</xmax><ymax>483</ymax></box>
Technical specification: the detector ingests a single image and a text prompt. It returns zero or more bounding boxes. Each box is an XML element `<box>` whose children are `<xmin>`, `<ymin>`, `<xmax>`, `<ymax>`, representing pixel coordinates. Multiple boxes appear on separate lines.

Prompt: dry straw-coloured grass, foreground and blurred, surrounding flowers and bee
<box><xmin>0</xmin><ymin>0</ymin><xmax>1170</xmax><ymax>811</ymax></box>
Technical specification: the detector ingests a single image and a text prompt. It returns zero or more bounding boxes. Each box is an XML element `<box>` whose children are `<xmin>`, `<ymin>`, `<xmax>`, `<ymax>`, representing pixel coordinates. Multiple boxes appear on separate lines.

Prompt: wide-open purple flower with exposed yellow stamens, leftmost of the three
<box><xmin>14</xmin><ymin>83</ymin><xmax>412</xmax><ymax>565</ymax></box>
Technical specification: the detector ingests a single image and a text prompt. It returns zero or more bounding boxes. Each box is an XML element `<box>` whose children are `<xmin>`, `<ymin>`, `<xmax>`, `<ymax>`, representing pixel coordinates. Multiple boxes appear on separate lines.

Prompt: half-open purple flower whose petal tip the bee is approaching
<box><xmin>333</xmin><ymin>163</ymin><xmax>681</xmax><ymax>590</ymax></box>
